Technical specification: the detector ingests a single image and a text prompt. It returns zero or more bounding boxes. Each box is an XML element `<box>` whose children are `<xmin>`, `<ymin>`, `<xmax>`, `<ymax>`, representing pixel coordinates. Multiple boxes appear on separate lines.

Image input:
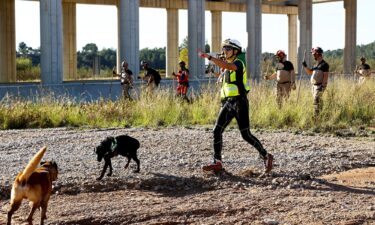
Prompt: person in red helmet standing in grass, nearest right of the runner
<box><xmin>264</xmin><ymin>50</ymin><xmax>296</xmax><ymax>108</ymax></box>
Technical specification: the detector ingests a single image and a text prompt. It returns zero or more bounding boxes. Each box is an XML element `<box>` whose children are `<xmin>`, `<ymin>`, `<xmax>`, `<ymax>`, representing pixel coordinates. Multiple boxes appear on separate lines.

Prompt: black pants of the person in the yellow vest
<box><xmin>214</xmin><ymin>96</ymin><xmax>267</xmax><ymax>160</ymax></box>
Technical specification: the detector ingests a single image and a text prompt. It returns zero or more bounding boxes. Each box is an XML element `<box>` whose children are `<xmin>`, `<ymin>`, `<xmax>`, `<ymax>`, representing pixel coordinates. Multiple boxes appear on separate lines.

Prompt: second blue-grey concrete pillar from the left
<box><xmin>117</xmin><ymin>0</ymin><xmax>140</xmax><ymax>79</ymax></box>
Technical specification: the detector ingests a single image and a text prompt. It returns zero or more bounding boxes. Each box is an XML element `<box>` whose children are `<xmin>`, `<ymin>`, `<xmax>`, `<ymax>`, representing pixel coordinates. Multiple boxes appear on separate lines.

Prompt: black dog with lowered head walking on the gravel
<box><xmin>95</xmin><ymin>135</ymin><xmax>140</xmax><ymax>180</ymax></box>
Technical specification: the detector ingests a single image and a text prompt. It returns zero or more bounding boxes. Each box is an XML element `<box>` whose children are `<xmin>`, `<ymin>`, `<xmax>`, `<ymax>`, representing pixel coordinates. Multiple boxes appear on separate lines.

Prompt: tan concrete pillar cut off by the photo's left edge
<box><xmin>0</xmin><ymin>0</ymin><xmax>16</xmax><ymax>83</ymax></box>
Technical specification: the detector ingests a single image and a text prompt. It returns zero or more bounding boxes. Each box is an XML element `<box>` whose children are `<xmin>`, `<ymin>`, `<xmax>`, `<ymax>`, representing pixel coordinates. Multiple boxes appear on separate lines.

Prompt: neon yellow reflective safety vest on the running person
<box><xmin>220</xmin><ymin>58</ymin><xmax>250</xmax><ymax>99</ymax></box>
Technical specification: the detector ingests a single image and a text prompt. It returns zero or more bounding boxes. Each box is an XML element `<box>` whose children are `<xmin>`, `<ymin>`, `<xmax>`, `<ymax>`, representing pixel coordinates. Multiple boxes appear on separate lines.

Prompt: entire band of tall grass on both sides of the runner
<box><xmin>0</xmin><ymin>79</ymin><xmax>375</xmax><ymax>131</ymax></box>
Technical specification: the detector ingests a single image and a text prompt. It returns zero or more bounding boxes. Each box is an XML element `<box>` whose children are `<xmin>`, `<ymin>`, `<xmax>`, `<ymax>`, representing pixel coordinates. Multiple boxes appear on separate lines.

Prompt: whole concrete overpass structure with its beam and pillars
<box><xmin>0</xmin><ymin>0</ymin><xmax>357</xmax><ymax>99</ymax></box>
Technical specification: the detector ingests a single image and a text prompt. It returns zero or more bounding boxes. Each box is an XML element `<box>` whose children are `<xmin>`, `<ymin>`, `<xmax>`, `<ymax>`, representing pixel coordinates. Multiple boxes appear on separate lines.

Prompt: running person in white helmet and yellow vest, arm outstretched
<box><xmin>198</xmin><ymin>39</ymin><xmax>273</xmax><ymax>173</ymax></box>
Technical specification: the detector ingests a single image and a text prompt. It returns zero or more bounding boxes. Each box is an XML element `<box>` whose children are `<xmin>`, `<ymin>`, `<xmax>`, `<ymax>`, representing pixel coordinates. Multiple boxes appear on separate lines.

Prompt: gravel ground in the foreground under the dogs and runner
<box><xmin>0</xmin><ymin>127</ymin><xmax>375</xmax><ymax>225</ymax></box>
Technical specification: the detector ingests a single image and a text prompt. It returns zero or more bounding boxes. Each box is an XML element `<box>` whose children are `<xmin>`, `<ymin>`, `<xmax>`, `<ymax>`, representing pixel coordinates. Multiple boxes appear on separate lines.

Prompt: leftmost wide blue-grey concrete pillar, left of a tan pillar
<box><xmin>40</xmin><ymin>0</ymin><xmax>64</xmax><ymax>84</ymax></box>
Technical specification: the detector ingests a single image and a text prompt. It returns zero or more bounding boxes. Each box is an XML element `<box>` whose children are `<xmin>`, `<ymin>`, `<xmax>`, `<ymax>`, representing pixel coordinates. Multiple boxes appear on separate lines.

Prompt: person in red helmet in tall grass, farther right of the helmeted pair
<box><xmin>302</xmin><ymin>47</ymin><xmax>329</xmax><ymax>119</ymax></box>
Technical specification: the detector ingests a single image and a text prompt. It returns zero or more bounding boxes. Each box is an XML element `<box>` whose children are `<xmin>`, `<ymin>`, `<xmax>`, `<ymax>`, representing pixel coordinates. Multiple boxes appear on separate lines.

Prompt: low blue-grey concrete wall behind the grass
<box><xmin>0</xmin><ymin>78</ymin><xmax>217</xmax><ymax>102</ymax></box>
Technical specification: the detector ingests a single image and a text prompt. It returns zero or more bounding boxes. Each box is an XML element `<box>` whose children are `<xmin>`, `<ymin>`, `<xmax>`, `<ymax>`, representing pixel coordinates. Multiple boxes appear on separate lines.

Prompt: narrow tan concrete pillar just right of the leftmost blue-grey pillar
<box><xmin>62</xmin><ymin>2</ymin><xmax>77</xmax><ymax>80</ymax></box>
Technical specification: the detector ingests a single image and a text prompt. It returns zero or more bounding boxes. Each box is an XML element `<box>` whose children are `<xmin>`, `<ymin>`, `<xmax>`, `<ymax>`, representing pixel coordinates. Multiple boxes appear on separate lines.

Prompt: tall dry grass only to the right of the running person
<box><xmin>250</xmin><ymin>79</ymin><xmax>375</xmax><ymax>131</ymax></box>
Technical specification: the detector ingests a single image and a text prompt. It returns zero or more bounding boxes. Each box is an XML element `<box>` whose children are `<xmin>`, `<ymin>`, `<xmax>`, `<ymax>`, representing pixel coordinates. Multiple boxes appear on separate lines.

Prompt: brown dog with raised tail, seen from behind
<box><xmin>7</xmin><ymin>147</ymin><xmax>58</xmax><ymax>225</ymax></box>
